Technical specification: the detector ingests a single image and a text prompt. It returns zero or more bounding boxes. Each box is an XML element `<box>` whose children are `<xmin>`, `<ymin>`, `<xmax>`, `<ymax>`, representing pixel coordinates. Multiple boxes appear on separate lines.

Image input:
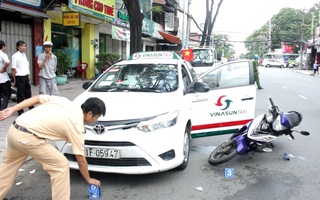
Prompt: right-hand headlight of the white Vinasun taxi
<box><xmin>138</xmin><ymin>110</ymin><xmax>179</xmax><ymax>132</ymax></box>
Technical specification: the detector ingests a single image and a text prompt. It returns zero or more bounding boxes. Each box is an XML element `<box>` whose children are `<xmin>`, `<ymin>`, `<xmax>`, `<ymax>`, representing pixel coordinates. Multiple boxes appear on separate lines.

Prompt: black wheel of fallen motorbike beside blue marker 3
<box><xmin>209</xmin><ymin>140</ymin><xmax>237</xmax><ymax>165</ymax></box>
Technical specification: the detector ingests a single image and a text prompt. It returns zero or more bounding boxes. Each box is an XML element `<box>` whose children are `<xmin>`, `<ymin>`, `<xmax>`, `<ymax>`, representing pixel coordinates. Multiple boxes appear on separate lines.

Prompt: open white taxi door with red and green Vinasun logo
<box><xmin>191</xmin><ymin>60</ymin><xmax>256</xmax><ymax>138</ymax></box>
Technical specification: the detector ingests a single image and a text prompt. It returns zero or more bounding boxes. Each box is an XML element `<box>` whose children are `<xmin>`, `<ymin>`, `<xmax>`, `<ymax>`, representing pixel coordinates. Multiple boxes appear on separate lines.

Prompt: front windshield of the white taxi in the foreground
<box><xmin>91</xmin><ymin>63</ymin><xmax>178</xmax><ymax>92</ymax></box>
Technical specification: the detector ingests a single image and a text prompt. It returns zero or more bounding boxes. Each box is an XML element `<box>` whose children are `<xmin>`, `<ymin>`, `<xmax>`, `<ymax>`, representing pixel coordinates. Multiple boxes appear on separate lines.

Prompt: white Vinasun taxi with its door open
<box><xmin>57</xmin><ymin>52</ymin><xmax>256</xmax><ymax>174</ymax></box>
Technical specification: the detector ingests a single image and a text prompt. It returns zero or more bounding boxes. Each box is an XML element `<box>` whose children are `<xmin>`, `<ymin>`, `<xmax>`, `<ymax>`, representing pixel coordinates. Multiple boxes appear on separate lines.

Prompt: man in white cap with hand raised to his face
<box><xmin>38</xmin><ymin>41</ymin><xmax>59</xmax><ymax>96</ymax></box>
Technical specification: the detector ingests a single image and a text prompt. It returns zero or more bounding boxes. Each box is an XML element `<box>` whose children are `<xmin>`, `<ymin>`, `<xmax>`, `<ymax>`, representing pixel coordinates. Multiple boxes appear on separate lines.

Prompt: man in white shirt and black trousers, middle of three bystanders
<box><xmin>11</xmin><ymin>40</ymin><xmax>34</xmax><ymax>115</ymax></box>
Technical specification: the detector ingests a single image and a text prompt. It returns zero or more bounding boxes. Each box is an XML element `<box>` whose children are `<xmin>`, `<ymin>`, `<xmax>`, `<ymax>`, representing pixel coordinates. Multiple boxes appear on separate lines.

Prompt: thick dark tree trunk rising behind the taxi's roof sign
<box><xmin>123</xmin><ymin>0</ymin><xmax>144</xmax><ymax>55</ymax></box>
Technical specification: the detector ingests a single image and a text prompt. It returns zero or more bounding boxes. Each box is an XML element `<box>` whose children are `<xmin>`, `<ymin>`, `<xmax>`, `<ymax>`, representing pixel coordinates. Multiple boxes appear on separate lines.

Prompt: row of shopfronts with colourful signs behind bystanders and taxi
<box><xmin>0</xmin><ymin>0</ymin><xmax>179</xmax><ymax>85</ymax></box>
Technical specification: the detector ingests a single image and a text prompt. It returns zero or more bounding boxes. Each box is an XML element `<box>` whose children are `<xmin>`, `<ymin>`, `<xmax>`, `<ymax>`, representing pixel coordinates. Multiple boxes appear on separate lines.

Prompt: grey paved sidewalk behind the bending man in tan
<box><xmin>0</xmin><ymin>78</ymin><xmax>90</xmax><ymax>163</ymax></box>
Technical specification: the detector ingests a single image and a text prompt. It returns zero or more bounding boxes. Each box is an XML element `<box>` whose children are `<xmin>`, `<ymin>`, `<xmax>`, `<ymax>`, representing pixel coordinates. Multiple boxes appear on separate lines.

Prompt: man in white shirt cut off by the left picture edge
<box><xmin>0</xmin><ymin>40</ymin><xmax>11</xmax><ymax>111</ymax></box>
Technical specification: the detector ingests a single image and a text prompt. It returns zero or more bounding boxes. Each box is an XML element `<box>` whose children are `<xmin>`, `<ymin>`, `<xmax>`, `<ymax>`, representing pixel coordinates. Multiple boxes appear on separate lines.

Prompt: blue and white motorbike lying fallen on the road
<box><xmin>209</xmin><ymin>97</ymin><xmax>310</xmax><ymax>165</ymax></box>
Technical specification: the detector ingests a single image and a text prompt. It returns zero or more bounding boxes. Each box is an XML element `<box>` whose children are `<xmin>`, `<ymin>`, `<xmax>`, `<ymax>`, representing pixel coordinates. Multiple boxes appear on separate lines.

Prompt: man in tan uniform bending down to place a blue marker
<box><xmin>0</xmin><ymin>95</ymin><xmax>106</xmax><ymax>200</ymax></box>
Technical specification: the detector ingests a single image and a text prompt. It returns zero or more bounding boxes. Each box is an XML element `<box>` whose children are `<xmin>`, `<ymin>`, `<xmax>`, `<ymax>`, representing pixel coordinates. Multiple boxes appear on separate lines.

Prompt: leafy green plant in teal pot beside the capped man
<box><xmin>53</xmin><ymin>50</ymin><xmax>72</xmax><ymax>85</ymax></box>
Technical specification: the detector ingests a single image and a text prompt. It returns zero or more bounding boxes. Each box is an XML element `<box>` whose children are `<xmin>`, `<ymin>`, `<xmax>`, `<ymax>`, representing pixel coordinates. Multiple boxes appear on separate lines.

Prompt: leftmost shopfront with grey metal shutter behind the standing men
<box><xmin>0</xmin><ymin>0</ymin><xmax>50</xmax><ymax>84</ymax></box>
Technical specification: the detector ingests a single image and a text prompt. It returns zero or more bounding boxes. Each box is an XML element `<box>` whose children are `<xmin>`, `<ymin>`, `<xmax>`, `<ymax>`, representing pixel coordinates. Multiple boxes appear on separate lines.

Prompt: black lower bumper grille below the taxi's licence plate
<box><xmin>64</xmin><ymin>153</ymin><xmax>151</xmax><ymax>167</ymax></box>
